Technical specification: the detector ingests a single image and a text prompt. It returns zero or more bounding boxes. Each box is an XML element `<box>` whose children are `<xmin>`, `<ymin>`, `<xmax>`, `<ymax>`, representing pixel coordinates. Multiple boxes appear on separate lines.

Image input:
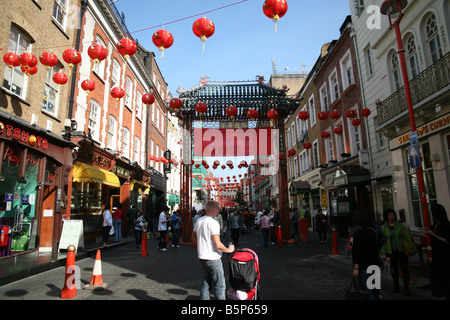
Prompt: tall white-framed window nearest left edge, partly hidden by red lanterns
<box><xmin>3</xmin><ymin>27</ymin><xmax>31</xmax><ymax>98</ymax></box>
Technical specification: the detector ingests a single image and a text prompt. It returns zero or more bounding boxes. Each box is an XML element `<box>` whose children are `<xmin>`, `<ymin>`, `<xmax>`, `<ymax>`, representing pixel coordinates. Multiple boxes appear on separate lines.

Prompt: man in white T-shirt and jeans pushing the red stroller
<box><xmin>192</xmin><ymin>200</ymin><xmax>234</xmax><ymax>300</ymax></box>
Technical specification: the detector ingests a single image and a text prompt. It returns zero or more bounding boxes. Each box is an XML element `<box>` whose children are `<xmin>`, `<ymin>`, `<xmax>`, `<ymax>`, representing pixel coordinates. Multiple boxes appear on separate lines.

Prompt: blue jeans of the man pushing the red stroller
<box><xmin>200</xmin><ymin>259</ymin><xmax>226</xmax><ymax>300</ymax></box>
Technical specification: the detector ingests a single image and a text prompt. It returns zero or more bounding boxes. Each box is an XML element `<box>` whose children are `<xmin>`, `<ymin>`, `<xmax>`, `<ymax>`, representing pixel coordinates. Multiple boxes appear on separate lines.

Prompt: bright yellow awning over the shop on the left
<box><xmin>73</xmin><ymin>162</ymin><xmax>120</xmax><ymax>188</ymax></box>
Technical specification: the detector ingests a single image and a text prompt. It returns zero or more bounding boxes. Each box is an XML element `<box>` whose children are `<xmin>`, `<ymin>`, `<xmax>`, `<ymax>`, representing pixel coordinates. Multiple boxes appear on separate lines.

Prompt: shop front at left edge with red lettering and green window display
<box><xmin>0</xmin><ymin>114</ymin><xmax>75</xmax><ymax>256</ymax></box>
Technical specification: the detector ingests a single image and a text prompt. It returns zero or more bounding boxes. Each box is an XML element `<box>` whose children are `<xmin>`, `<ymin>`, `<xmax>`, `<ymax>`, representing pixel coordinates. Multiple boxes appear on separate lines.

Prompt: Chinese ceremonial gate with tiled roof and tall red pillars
<box><xmin>176</xmin><ymin>77</ymin><xmax>300</xmax><ymax>243</ymax></box>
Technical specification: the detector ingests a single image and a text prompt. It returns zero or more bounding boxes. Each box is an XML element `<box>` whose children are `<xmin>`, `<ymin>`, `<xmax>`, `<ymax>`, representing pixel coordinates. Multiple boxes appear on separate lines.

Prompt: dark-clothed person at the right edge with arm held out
<box><xmin>419</xmin><ymin>204</ymin><xmax>450</xmax><ymax>300</ymax></box>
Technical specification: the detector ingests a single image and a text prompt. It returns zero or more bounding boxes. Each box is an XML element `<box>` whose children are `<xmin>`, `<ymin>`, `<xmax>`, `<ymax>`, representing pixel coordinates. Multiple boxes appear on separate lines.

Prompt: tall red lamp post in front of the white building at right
<box><xmin>380</xmin><ymin>0</ymin><xmax>432</xmax><ymax>262</ymax></box>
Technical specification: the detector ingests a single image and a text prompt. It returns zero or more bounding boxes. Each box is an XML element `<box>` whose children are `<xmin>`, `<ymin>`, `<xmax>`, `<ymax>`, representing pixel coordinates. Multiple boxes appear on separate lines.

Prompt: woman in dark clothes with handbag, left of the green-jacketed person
<box><xmin>352</xmin><ymin>209</ymin><xmax>379</xmax><ymax>300</ymax></box>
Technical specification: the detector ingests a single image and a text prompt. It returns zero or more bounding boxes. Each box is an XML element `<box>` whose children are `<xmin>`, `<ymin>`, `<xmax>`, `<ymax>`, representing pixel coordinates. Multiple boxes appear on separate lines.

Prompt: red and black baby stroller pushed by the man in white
<box><xmin>227</xmin><ymin>249</ymin><xmax>261</xmax><ymax>300</ymax></box>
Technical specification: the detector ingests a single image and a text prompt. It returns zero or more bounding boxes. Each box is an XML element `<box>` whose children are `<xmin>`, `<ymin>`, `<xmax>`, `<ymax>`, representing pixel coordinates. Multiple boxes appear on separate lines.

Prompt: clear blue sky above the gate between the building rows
<box><xmin>115</xmin><ymin>0</ymin><xmax>350</xmax><ymax>96</ymax></box>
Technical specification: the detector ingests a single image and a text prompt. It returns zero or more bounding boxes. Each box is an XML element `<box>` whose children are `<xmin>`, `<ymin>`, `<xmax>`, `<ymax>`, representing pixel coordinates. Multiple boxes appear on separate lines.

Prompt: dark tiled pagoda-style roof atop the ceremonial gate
<box><xmin>174</xmin><ymin>81</ymin><xmax>300</xmax><ymax>122</ymax></box>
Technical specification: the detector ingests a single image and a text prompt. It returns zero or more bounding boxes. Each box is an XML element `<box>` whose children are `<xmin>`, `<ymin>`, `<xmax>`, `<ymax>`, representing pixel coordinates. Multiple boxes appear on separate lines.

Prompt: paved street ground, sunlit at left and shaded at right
<box><xmin>0</xmin><ymin>231</ymin><xmax>442</xmax><ymax>309</ymax></box>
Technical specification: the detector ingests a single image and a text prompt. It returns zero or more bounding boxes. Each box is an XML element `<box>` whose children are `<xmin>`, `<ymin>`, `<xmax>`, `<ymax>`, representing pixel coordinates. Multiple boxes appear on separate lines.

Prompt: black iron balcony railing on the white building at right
<box><xmin>377</xmin><ymin>53</ymin><xmax>450</xmax><ymax>126</ymax></box>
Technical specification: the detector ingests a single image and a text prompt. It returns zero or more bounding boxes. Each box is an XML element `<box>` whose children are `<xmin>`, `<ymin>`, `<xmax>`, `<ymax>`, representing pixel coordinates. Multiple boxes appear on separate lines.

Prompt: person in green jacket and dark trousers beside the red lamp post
<box><xmin>381</xmin><ymin>209</ymin><xmax>415</xmax><ymax>295</ymax></box>
